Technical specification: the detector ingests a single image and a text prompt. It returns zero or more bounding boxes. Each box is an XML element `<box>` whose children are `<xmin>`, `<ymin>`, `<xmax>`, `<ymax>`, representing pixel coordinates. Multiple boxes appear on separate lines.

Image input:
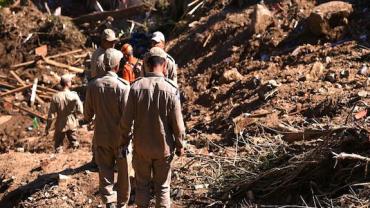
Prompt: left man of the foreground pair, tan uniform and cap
<box><xmin>84</xmin><ymin>48</ymin><xmax>130</xmax><ymax>207</ymax></box>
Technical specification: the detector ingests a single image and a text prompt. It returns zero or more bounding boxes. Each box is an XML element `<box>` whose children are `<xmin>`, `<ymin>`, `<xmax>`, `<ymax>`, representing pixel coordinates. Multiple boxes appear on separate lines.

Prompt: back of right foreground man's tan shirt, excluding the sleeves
<box><xmin>128</xmin><ymin>73</ymin><xmax>179</xmax><ymax>159</ymax></box>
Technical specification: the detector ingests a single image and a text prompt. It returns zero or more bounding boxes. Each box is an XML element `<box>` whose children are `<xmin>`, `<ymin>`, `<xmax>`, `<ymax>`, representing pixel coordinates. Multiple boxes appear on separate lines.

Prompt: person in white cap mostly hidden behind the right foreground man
<box><xmin>144</xmin><ymin>31</ymin><xmax>177</xmax><ymax>84</ymax></box>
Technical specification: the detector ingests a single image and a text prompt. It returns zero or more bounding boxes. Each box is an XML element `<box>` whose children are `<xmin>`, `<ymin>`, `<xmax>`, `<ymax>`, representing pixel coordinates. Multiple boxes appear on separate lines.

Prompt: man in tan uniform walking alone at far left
<box><xmin>45</xmin><ymin>74</ymin><xmax>83</xmax><ymax>153</ymax></box>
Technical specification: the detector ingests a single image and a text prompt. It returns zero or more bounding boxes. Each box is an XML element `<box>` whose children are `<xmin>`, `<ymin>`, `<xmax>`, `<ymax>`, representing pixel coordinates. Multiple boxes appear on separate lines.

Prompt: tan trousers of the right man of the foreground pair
<box><xmin>132</xmin><ymin>153</ymin><xmax>173</xmax><ymax>208</ymax></box>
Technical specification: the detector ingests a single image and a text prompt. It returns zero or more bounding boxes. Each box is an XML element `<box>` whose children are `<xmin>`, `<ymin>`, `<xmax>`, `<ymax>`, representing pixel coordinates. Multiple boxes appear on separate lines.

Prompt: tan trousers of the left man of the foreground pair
<box><xmin>95</xmin><ymin>145</ymin><xmax>131</xmax><ymax>207</ymax></box>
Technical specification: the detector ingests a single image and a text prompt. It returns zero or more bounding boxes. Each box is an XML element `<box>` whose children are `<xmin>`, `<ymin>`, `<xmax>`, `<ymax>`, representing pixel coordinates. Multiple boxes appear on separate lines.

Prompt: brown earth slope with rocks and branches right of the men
<box><xmin>169</xmin><ymin>0</ymin><xmax>370</xmax><ymax>207</ymax></box>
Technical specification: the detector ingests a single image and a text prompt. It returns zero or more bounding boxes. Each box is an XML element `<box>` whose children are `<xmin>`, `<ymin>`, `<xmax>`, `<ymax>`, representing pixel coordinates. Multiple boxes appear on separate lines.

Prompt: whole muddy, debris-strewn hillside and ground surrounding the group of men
<box><xmin>0</xmin><ymin>0</ymin><xmax>370</xmax><ymax>207</ymax></box>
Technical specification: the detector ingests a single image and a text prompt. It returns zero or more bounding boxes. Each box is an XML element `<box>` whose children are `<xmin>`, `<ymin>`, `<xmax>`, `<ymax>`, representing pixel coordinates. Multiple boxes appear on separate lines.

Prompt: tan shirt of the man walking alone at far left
<box><xmin>46</xmin><ymin>90</ymin><xmax>83</xmax><ymax>132</ymax></box>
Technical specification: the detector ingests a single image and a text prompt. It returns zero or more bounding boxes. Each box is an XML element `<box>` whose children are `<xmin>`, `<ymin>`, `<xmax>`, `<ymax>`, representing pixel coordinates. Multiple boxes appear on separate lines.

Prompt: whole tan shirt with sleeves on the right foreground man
<box><xmin>120</xmin><ymin>72</ymin><xmax>185</xmax><ymax>159</ymax></box>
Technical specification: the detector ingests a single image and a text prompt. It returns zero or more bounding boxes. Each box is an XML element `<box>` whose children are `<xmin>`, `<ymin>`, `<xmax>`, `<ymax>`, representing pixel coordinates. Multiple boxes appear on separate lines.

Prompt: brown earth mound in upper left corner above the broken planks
<box><xmin>0</xmin><ymin>4</ymin><xmax>86</xmax><ymax>68</ymax></box>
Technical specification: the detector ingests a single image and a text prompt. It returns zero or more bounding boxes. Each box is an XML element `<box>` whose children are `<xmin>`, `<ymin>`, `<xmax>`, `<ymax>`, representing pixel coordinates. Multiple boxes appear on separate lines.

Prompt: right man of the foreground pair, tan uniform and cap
<box><xmin>120</xmin><ymin>47</ymin><xmax>185</xmax><ymax>208</ymax></box>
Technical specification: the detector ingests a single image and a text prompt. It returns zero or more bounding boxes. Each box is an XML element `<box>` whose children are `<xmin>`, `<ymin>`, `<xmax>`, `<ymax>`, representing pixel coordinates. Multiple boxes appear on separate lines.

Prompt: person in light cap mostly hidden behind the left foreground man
<box><xmin>87</xmin><ymin>29</ymin><xmax>118</xmax><ymax>81</ymax></box>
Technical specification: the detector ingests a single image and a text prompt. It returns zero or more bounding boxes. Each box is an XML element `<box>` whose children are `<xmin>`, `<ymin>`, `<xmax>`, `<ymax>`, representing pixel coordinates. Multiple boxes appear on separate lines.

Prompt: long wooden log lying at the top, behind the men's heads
<box><xmin>72</xmin><ymin>4</ymin><xmax>150</xmax><ymax>24</ymax></box>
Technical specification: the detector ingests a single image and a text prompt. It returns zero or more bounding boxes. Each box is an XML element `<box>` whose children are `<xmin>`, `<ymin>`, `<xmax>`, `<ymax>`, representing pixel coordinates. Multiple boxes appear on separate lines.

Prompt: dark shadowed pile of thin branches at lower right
<box><xmin>221</xmin><ymin>127</ymin><xmax>370</xmax><ymax>207</ymax></box>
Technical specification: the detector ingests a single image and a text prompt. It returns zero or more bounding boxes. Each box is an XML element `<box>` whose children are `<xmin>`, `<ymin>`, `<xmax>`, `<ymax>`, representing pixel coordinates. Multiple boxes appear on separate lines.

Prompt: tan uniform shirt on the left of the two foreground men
<box><xmin>84</xmin><ymin>71</ymin><xmax>130</xmax><ymax>147</ymax></box>
